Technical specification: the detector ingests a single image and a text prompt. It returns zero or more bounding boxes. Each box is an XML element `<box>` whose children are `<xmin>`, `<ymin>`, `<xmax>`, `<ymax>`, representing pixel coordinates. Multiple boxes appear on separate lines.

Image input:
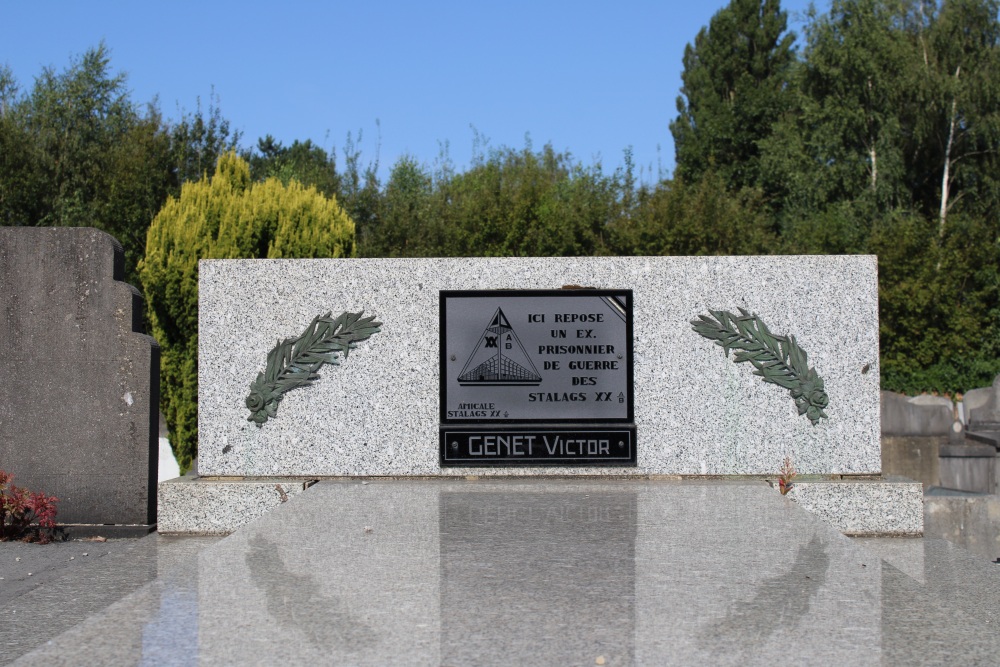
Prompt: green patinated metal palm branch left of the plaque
<box><xmin>246</xmin><ymin>311</ymin><xmax>382</xmax><ymax>426</ymax></box>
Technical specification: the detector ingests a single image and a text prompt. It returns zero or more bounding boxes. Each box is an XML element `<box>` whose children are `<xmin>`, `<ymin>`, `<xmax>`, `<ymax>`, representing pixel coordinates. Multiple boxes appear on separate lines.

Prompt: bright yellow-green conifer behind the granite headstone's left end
<box><xmin>139</xmin><ymin>152</ymin><xmax>354</xmax><ymax>471</ymax></box>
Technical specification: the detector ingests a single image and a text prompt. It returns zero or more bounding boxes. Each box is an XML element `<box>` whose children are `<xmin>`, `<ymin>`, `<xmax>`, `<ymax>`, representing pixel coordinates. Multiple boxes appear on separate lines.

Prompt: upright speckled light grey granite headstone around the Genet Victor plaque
<box><xmin>199</xmin><ymin>256</ymin><xmax>881</xmax><ymax>476</ymax></box>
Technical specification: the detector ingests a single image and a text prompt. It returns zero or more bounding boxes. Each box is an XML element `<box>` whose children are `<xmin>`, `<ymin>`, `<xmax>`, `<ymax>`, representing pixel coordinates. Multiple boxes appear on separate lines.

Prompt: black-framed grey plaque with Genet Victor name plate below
<box><xmin>440</xmin><ymin>290</ymin><xmax>635</xmax><ymax>465</ymax></box>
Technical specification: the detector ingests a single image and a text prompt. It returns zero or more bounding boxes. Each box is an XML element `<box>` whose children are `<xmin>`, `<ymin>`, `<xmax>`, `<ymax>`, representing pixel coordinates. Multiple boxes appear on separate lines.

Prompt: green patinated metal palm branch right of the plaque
<box><xmin>691</xmin><ymin>308</ymin><xmax>830</xmax><ymax>426</ymax></box>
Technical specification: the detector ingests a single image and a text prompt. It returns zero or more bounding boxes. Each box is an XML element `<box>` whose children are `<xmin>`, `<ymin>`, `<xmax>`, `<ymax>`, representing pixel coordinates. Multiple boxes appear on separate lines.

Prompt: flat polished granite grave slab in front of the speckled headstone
<box><xmin>18</xmin><ymin>479</ymin><xmax>1000</xmax><ymax>665</ymax></box>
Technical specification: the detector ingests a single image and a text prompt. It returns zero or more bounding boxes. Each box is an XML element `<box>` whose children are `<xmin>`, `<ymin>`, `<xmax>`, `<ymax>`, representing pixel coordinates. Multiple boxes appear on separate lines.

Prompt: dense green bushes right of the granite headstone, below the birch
<box><xmin>870</xmin><ymin>213</ymin><xmax>1000</xmax><ymax>394</ymax></box>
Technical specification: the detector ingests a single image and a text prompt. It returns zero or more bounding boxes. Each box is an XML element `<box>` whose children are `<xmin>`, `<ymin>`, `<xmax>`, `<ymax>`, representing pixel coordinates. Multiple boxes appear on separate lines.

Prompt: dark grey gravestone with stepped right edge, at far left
<box><xmin>0</xmin><ymin>227</ymin><xmax>160</xmax><ymax>534</ymax></box>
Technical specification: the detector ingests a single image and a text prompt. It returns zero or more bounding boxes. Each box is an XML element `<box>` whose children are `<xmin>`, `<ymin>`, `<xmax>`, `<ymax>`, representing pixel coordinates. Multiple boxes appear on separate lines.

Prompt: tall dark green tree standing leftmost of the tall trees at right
<box><xmin>670</xmin><ymin>0</ymin><xmax>795</xmax><ymax>189</ymax></box>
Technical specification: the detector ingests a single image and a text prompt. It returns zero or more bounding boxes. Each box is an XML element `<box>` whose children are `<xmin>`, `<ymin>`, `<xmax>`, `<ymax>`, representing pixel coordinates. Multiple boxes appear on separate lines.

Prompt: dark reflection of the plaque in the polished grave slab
<box><xmin>438</xmin><ymin>485</ymin><xmax>638</xmax><ymax>665</ymax></box>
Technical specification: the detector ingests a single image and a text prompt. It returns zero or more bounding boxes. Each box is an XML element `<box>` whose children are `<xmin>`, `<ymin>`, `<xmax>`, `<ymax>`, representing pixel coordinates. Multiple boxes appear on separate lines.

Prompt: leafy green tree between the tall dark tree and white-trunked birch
<box><xmin>761</xmin><ymin>0</ymin><xmax>915</xmax><ymax>224</ymax></box>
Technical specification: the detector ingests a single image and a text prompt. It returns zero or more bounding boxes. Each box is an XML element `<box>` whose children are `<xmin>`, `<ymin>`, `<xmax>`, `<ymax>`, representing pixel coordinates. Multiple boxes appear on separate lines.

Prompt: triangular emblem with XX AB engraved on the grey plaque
<box><xmin>458</xmin><ymin>308</ymin><xmax>542</xmax><ymax>386</ymax></box>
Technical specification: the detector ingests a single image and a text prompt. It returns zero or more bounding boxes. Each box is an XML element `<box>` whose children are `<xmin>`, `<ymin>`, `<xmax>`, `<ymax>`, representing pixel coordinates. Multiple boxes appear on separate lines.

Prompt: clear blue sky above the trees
<box><xmin>0</xmin><ymin>0</ymin><xmax>827</xmax><ymax>182</ymax></box>
